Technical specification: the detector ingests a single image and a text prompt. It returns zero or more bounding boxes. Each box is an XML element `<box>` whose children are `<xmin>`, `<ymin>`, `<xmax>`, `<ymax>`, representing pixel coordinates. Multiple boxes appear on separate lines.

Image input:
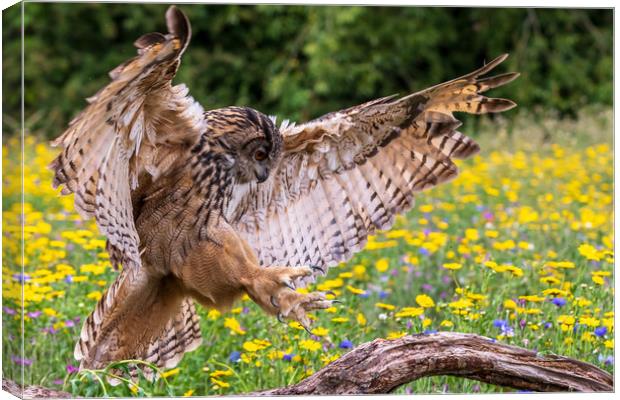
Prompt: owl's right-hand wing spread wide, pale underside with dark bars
<box><xmin>229</xmin><ymin>55</ymin><xmax>518</xmax><ymax>282</ymax></box>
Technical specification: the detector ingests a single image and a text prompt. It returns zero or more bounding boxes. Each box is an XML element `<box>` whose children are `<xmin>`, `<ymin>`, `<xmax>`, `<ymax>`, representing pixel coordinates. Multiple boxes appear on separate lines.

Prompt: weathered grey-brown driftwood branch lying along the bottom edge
<box><xmin>2</xmin><ymin>332</ymin><xmax>613</xmax><ymax>398</ymax></box>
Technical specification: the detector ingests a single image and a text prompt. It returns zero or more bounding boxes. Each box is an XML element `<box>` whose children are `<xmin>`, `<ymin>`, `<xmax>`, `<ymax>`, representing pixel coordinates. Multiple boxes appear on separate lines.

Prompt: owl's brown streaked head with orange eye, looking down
<box><xmin>205</xmin><ymin>107</ymin><xmax>282</xmax><ymax>183</ymax></box>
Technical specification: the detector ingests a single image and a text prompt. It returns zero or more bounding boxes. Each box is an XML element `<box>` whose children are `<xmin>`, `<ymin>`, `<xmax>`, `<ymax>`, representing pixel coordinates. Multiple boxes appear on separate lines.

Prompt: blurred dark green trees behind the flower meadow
<box><xmin>2</xmin><ymin>3</ymin><xmax>613</xmax><ymax>137</ymax></box>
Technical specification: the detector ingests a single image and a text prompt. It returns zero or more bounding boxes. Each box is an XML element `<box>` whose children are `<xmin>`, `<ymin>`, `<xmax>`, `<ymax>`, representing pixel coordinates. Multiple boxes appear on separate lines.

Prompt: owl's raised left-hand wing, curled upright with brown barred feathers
<box><xmin>50</xmin><ymin>6</ymin><xmax>204</xmax><ymax>265</ymax></box>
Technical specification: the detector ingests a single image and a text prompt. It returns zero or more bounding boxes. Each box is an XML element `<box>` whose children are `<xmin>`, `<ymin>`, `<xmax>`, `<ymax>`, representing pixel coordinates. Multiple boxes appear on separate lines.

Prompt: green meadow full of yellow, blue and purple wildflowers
<box><xmin>2</xmin><ymin>108</ymin><xmax>614</xmax><ymax>396</ymax></box>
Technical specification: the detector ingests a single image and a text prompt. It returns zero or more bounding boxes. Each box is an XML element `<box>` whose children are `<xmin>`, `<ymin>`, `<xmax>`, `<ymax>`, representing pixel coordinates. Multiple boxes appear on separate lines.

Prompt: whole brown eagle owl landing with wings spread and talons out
<box><xmin>51</xmin><ymin>6</ymin><xmax>518</xmax><ymax>376</ymax></box>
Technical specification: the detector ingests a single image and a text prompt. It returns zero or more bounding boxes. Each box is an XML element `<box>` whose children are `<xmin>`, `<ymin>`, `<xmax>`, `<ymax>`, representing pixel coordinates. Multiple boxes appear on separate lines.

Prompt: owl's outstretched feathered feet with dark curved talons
<box><xmin>244</xmin><ymin>267</ymin><xmax>338</xmax><ymax>331</ymax></box>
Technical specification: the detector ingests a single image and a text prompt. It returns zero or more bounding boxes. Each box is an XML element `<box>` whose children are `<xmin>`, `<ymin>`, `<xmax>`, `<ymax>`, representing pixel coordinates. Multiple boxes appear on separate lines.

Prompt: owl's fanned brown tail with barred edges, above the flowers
<box><xmin>74</xmin><ymin>268</ymin><xmax>202</xmax><ymax>378</ymax></box>
